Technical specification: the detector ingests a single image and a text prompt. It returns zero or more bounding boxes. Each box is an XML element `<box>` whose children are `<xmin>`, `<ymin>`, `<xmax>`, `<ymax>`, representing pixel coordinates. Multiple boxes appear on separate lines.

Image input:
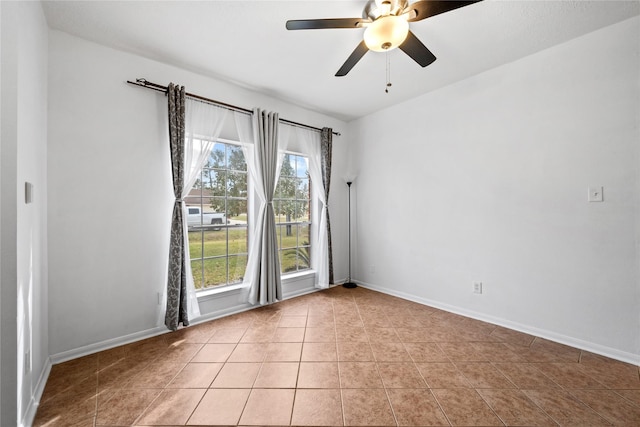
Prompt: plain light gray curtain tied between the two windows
<box><xmin>249</xmin><ymin>108</ymin><xmax>282</xmax><ymax>305</ymax></box>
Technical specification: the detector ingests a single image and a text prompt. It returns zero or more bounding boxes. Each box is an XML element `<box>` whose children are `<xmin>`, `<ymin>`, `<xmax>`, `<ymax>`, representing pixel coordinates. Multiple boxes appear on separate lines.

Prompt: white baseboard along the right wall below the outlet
<box><xmin>356</xmin><ymin>281</ymin><xmax>640</xmax><ymax>366</ymax></box>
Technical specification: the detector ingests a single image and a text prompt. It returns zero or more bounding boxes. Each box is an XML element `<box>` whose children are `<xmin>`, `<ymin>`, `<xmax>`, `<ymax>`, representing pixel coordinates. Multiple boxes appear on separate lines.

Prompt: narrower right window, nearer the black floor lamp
<box><xmin>273</xmin><ymin>153</ymin><xmax>311</xmax><ymax>273</ymax></box>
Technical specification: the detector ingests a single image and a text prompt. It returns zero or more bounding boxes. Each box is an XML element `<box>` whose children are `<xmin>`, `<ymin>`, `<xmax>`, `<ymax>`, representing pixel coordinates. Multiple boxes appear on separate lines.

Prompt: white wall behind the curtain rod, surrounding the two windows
<box><xmin>48</xmin><ymin>31</ymin><xmax>346</xmax><ymax>356</ymax></box>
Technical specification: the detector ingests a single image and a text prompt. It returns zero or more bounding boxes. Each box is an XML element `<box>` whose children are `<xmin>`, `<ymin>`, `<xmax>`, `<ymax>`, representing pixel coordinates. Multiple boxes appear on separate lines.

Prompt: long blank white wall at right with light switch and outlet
<box><xmin>350</xmin><ymin>18</ymin><xmax>640</xmax><ymax>363</ymax></box>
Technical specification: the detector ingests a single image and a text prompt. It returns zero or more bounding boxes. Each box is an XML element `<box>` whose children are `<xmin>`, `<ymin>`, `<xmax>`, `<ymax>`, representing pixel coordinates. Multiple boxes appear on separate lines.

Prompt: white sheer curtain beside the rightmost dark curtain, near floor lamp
<box><xmin>296</xmin><ymin>128</ymin><xmax>329</xmax><ymax>289</ymax></box>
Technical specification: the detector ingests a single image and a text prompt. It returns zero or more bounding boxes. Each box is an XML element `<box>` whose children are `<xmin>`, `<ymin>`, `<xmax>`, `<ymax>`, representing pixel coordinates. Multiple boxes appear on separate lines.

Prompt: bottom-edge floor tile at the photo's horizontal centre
<box><xmin>291</xmin><ymin>389</ymin><xmax>343</xmax><ymax>426</ymax></box>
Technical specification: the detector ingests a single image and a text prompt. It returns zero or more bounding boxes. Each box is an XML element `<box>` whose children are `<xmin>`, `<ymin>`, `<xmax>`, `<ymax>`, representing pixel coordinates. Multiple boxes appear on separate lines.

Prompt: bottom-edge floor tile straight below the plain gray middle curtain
<box><xmin>240</xmin><ymin>389</ymin><xmax>295</xmax><ymax>426</ymax></box>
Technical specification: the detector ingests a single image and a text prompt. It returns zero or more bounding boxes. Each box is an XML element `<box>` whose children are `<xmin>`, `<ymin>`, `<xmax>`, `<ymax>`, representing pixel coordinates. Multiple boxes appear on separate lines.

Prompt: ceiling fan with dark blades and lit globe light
<box><xmin>287</xmin><ymin>0</ymin><xmax>480</xmax><ymax>77</ymax></box>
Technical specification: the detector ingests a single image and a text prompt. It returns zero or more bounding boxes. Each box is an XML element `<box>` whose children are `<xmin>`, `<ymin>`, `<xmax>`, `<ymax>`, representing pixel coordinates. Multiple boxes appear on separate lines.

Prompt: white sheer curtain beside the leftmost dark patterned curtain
<box><xmin>182</xmin><ymin>98</ymin><xmax>227</xmax><ymax>320</ymax></box>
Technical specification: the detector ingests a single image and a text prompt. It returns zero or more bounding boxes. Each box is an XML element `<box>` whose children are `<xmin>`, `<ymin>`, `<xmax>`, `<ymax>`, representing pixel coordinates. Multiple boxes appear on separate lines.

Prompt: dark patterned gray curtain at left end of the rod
<box><xmin>164</xmin><ymin>83</ymin><xmax>189</xmax><ymax>331</ymax></box>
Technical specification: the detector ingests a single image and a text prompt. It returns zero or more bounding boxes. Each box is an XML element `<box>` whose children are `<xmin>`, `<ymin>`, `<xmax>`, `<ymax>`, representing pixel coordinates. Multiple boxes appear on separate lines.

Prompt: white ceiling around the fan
<box><xmin>42</xmin><ymin>0</ymin><xmax>640</xmax><ymax>121</ymax></box>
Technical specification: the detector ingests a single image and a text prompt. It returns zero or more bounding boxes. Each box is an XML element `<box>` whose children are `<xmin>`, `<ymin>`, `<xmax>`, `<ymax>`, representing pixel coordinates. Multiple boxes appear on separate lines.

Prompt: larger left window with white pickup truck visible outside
<box><xmin>185</xmin><ymin>142</ymin><xmax>248</xmax><ymax>290</ymax></box>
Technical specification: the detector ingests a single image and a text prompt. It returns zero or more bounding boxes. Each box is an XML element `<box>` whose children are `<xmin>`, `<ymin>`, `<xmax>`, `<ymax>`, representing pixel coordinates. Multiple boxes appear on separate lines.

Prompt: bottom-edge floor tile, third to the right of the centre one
<box><xmin>431</xmin><ymin>388</ymin><xmax>503</xmax><ymax>426</ymax></box>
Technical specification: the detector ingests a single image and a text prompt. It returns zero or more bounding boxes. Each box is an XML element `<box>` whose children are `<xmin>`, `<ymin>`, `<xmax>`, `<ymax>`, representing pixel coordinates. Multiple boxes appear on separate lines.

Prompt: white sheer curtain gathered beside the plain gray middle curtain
<box><xmin>234</xmin><ymin>112</ymin><xmax>290</xmax><ymax>304</ymax></box>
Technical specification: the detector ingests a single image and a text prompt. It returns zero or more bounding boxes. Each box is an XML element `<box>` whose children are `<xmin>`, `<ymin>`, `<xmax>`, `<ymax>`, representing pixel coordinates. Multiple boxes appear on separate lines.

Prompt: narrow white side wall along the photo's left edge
<box><xmin>0</xmin><ymin>2</ymin><xmax>50</xmax><ymax>426</ymax></box>
